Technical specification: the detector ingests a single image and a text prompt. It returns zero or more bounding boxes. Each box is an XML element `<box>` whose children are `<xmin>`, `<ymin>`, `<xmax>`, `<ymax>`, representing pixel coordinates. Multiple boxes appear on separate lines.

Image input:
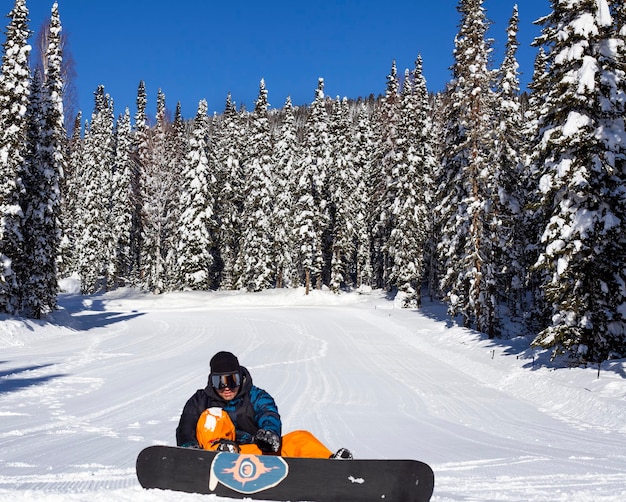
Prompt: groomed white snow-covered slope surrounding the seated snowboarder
<box><xmin>0</xmin><ymin>282</ymin><xmax>626</xmax><ymax>502</ymax></box>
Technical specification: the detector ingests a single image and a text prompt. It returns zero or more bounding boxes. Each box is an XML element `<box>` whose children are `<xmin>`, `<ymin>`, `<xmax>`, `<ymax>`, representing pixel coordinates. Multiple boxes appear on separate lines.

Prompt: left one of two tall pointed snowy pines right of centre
<box><xmin>370</xmin><ymin>61</ymin><xmax>402</xmax><ymax>288</ymax></box>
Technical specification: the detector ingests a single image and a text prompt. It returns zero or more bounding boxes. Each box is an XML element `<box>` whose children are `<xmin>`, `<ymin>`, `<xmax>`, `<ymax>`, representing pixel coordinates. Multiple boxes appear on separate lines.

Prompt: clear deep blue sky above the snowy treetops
<box><xmin>9</xmin><ymin>0</ymin><xmax>550</xmax><ymax>118</ymax></box>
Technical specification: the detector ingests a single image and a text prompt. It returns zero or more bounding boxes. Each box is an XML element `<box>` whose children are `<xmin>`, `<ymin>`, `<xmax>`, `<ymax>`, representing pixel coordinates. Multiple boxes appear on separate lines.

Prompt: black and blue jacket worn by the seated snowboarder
<box><xmin>176</xmin><ymin>366</ymin><xmax>282</xmax><ymax>446</ymax></box>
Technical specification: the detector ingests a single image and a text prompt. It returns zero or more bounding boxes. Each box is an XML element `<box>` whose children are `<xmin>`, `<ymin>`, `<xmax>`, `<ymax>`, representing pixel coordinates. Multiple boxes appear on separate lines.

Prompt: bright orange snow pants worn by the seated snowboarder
<box><xmin>196</xmin><ymin>408</ymin><xmax>332</xmax><ymax>458</ymax></box>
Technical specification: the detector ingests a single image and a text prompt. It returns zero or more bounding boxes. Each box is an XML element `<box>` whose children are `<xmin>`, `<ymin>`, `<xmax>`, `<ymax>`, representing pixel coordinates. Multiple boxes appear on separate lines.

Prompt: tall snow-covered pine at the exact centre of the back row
<box><xmin>296</xmin><ymin>78</ymin><xmax>330</xmax><ymax>294</ymax></box>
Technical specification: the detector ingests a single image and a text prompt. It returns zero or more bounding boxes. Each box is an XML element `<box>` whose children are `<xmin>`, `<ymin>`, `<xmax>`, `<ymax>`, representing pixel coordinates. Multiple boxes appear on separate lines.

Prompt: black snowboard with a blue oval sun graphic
<box><xmin>136</xmin><ymin>446</ymin><xmax>435</xmax><ymax>502</ymax></box>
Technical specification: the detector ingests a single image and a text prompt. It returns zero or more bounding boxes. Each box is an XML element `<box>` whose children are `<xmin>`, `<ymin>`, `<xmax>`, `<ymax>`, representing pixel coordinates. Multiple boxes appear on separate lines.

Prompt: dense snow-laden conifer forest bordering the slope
<box><xmin>0</xmin><ymin>0</ymin><xmax>626</xmax><ymax>364</ymax></box>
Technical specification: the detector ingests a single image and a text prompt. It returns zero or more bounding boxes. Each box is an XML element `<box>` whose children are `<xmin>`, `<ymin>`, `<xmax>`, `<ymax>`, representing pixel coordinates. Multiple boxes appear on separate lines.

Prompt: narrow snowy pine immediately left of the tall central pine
<box><xmin>272</xmin><ymin>97</ymin><xmax>300</xmax><ymax>288</ymax></box>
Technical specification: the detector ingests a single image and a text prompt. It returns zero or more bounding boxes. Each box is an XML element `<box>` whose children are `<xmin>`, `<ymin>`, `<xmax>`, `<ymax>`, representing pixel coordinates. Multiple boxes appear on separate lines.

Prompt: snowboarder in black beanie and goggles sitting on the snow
<box><xmin>176</xmin><ymin>352</ymin><xmax>352</xmax><ymax>460</ymax></box>
